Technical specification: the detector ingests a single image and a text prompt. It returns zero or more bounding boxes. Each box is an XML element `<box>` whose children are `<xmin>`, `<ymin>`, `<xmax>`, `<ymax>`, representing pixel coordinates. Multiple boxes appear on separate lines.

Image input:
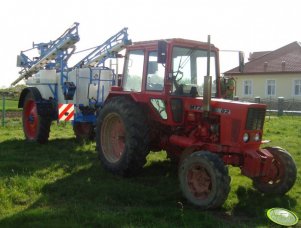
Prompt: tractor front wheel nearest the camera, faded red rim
<box><xmin>179</xmin><ymin>151</ymin><xmax>230</xmax><ymax>209</ymax></box>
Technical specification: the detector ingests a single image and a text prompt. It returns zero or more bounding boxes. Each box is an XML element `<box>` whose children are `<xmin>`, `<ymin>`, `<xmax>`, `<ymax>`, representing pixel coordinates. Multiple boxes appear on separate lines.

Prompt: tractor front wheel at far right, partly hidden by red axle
<box><xmin>253</xmin><ymin>147</ymin><xmax>297</xmax><ymax>195</ymax></box>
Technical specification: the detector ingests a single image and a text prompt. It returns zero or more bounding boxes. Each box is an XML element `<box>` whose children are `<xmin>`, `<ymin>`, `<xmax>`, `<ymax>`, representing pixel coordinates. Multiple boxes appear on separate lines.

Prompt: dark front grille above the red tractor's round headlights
<box><xmin>246</xmin><ymin>108</ymin><xmax>265</xmax><ymax>130</ymax></box>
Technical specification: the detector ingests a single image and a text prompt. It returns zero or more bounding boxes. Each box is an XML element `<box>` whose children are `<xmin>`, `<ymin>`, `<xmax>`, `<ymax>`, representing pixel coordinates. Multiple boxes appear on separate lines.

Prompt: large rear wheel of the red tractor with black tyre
<box><xmin>96</xmin><ymin>97</ymin><xmax>149</xmax><ymax>176</ymax></box>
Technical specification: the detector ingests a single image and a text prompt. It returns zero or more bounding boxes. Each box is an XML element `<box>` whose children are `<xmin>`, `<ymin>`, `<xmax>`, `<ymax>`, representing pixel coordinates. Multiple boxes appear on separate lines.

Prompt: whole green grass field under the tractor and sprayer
<box><xmin>0</xmin><ymin>117</ymin><xmax>301</xmax><ymax>227</ymax></box>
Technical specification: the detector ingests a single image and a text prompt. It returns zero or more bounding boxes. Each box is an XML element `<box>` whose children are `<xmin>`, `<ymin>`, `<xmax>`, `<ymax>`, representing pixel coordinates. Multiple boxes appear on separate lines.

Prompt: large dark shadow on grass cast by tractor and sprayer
<box><xmin>0</xmin><ymin>139</ymin><xmax>227</xmax><ymax>227</ymax></box>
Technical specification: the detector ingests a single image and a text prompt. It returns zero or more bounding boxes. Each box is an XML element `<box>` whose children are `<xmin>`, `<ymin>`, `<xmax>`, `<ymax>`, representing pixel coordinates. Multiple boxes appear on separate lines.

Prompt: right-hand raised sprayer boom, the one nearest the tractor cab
<box><xmin>72</xmin><ymin>28</ymin><xmax>131</xmax><ymax>69</ymax></box>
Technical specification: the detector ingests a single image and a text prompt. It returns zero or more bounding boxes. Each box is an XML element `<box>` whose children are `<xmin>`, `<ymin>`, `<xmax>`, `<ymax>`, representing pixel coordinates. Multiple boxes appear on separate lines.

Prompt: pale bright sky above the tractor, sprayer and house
<box><xmin>0</xmin><ymin>0</ymin><xmax>301</xmax><ymax>88</ymax></box>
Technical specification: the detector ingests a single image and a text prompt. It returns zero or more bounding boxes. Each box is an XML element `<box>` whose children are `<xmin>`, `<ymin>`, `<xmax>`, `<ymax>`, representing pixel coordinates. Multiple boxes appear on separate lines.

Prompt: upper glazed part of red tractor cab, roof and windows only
<box><xmin>122</xmin><ymin>39</ymin><xmax>219</xmax><ymax>97</ymax></box>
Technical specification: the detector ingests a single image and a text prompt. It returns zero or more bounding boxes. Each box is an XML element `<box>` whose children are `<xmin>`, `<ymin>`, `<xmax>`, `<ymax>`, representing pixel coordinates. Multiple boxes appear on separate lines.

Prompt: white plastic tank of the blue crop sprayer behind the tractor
<box><xmin>26</xmin><ymin>68</ymin><xmax>114</xmax><ymax>110</ymax></box>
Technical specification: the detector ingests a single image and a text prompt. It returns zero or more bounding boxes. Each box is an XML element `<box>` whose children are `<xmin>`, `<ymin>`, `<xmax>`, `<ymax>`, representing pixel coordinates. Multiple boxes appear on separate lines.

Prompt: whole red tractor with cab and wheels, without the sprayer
<box><xmin>96</xmin><ymin>39</ymin><xmax>297</xmax><ymax>209</ymax></box>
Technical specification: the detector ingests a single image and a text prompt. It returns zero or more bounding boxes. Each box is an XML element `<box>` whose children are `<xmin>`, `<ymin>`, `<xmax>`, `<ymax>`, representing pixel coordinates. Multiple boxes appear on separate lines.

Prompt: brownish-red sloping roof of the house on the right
<box><xmin>224</xmin><ymin>41</ymin><xmax>301</xmax><ymax>75</ymax></box>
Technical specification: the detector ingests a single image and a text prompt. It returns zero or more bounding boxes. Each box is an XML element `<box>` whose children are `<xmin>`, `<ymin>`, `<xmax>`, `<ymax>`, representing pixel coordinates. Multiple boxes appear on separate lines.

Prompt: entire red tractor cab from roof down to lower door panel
<box><xmin>108</xmin><ymin>39</ymin><xmax>221</xmax><ymax>126</ymax></box>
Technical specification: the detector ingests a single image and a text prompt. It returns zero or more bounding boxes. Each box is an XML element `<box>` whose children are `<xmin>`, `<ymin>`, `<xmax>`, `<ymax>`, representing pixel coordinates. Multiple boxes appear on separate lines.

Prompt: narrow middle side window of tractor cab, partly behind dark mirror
<box><xmin>146</xmin><ymin>51</ymin><xmax>165</xmax><ymax>91</ymax></box>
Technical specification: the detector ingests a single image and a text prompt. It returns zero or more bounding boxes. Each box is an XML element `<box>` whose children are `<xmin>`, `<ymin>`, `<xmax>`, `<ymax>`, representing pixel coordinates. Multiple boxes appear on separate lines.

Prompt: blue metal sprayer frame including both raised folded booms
<box><xmin>13</xmin><ymin>23</ymin><xmax>127</xmax><ymax>125</ymax></box>
